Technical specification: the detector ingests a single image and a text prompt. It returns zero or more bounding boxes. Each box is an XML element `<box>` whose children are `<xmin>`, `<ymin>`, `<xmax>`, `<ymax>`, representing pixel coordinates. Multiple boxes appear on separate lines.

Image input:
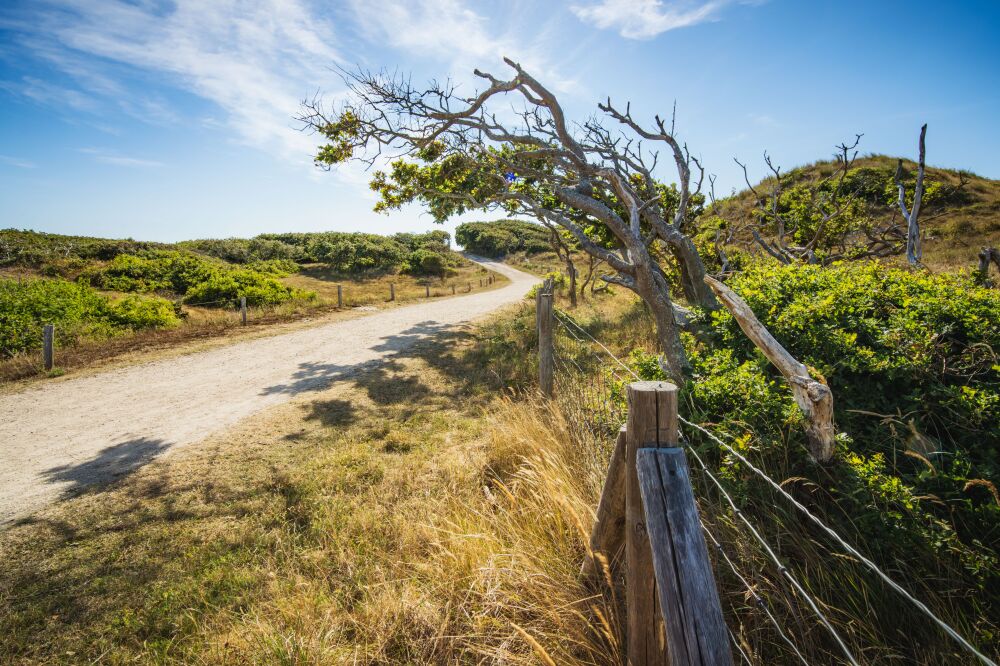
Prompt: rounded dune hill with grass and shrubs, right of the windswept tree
<box><xmin>716</xmin><ymin>155</ymin><xmax>1000</xmax><ymax>268</ymax></box>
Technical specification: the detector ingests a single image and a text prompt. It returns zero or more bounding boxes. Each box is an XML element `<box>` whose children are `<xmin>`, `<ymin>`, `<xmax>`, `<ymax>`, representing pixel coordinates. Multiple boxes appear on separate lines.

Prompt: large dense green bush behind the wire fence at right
<box><xmin>633</xmin><ymin>262</ymin><xmax>1000</xmax><ymax>590</ymax></box>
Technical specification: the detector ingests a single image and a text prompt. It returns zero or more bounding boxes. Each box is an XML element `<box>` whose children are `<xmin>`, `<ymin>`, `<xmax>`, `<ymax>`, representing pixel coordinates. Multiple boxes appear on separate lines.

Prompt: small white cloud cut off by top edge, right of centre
<box><xmin>570</xmin><ymin>0</ymin><xmax>729</xmax><ymax>39</ymax></box>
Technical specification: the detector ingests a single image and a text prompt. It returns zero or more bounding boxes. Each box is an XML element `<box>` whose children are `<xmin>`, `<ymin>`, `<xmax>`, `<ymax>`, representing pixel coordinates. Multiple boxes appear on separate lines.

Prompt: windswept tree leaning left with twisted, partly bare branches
<box><xmin>300</xmin><ymin>59</ymin><xmax>719</xmax><ymax>379</ymax></box>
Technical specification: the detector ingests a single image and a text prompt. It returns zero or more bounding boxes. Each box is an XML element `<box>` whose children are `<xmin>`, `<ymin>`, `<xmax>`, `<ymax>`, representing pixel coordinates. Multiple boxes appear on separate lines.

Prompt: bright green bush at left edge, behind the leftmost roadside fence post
<box><xmin>0</xmin><ymin>278</ymin><xmax>180</xmax><ymax>358</ymax></box>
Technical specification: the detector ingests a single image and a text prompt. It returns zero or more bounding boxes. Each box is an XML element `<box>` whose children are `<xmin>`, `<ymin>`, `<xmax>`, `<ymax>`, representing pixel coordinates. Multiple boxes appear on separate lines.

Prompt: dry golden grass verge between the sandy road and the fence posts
<box><xmin>0</xmin><ymin>308</ymin><xmax>618</xmax><ymax>664</ymax></box>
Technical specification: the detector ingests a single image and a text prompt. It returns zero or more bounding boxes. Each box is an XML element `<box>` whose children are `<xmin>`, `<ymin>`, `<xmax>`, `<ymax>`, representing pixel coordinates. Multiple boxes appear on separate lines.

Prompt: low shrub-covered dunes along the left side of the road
<box><xmin>0</xmin><ymin>229</ymin><xmax>474</xmax><ymax>377</ymax></box>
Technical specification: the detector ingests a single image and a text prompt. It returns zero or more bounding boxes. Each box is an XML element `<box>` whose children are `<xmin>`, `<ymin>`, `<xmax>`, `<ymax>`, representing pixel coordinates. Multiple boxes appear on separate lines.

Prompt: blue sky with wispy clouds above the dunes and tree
<box><xmin>0</xmin><ymin>0</ymin><xmax>1000</xmax><ymax>241</ymax></box>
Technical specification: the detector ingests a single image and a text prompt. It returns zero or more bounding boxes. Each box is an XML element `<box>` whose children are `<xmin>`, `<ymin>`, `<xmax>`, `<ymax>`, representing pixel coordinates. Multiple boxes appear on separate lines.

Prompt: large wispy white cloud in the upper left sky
<box><xmin>8</xmin><ymin>0</ymin><xmax>339</xmax><ymax>160</ymax></box>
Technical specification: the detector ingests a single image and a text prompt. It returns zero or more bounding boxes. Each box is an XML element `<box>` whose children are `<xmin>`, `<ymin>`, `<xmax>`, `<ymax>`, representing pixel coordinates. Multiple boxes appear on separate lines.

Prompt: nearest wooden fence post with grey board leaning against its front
<box><xmin>625</xmin><ymin>382</ymin><xmax>733</xmax><ymax>666</ymax></box>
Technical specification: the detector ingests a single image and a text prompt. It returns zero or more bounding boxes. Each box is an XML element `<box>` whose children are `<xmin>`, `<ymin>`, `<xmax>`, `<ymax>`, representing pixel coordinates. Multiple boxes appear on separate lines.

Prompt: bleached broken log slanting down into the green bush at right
<box><xmin>705</xmin><ymin>276</ymin><xmax>835</xmax><ymax>463</ymax></box>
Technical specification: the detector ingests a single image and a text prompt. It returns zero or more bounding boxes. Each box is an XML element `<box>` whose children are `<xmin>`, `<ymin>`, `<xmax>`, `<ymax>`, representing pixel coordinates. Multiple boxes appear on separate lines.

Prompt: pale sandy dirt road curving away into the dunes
<box><xmin>0</xmin><ymin>260</ymin><xmax>537</xmax><ymax>527</ymax></box>
